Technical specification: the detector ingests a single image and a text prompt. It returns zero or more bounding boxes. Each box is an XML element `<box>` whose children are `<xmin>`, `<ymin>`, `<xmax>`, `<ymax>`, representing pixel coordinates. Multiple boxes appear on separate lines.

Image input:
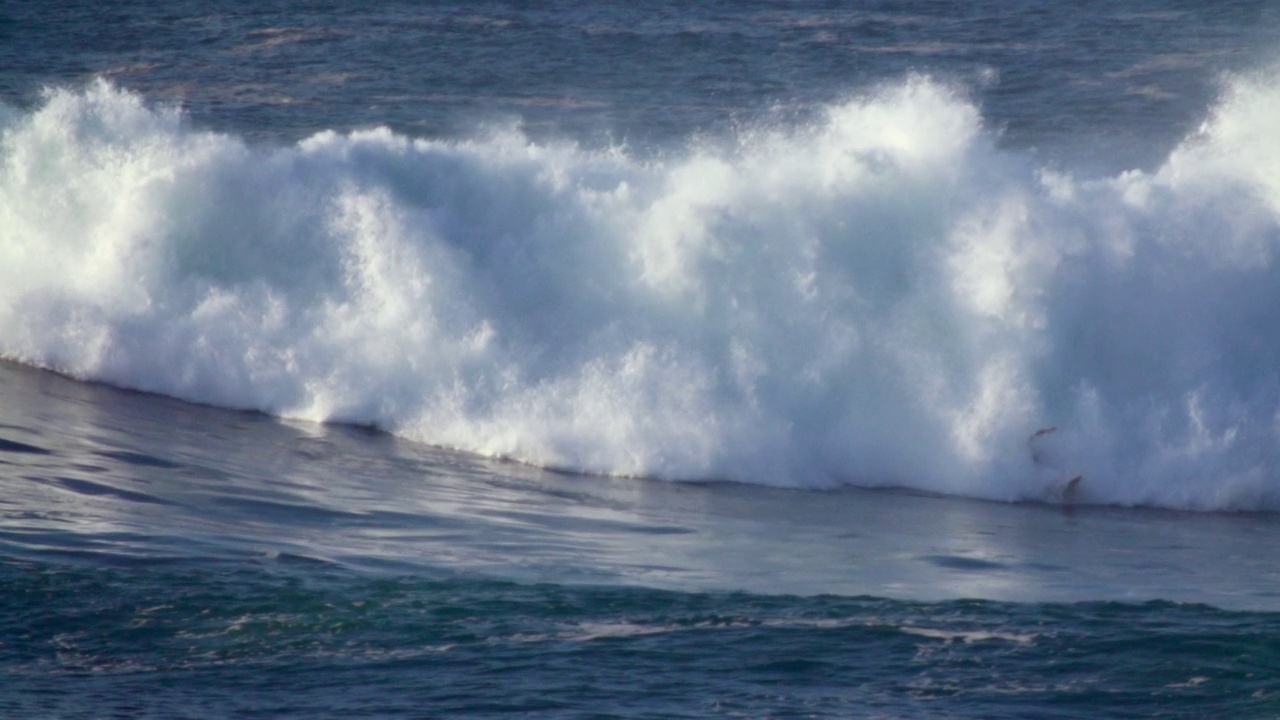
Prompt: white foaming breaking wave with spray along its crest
<box><xmin>0</xmin><ymin>77</ymin><xmax>1280</xmax><ymax>509</ymax></box>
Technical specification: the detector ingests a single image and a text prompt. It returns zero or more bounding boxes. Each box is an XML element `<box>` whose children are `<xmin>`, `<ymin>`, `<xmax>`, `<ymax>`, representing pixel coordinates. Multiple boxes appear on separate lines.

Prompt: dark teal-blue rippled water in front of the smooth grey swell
<box><xmin>10</xmin><ymin>564</ymin><xmax>1280</xmax><ymax>717</ymax></box>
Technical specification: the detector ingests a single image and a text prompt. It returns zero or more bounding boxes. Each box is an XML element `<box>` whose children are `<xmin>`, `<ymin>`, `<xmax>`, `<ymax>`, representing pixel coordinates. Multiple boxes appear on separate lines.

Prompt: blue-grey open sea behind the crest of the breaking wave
<box><xmin>0</xmin><ymin>0</ymin><xmax>1280</xmax><ymax>163</ymax></box>
